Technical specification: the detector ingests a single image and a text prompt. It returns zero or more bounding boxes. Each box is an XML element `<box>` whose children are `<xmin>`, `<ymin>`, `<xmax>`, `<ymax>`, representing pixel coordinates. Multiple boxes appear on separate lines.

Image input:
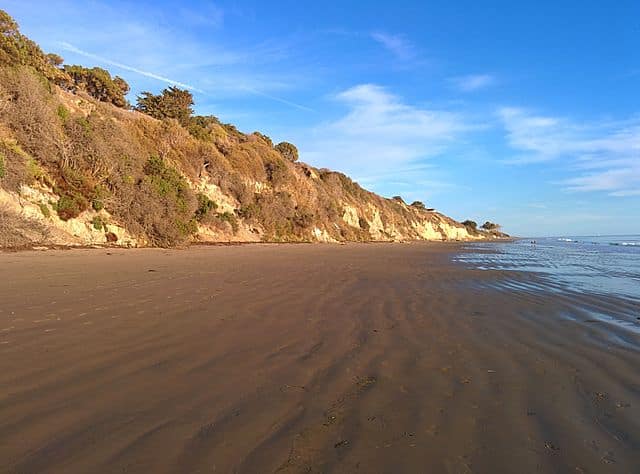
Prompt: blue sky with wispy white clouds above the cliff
<box><xmin>0</xmin><ymin>0</ymin><xmax>640</xmax><ymax>236</ymax></box>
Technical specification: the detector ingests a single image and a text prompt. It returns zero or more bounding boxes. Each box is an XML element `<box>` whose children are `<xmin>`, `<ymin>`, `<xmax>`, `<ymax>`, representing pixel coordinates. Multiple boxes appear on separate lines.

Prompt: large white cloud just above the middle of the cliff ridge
<box><xmin>299</xmin><ymin>84</ymin><xmax>471</xmax><ymax>183</ymax></box>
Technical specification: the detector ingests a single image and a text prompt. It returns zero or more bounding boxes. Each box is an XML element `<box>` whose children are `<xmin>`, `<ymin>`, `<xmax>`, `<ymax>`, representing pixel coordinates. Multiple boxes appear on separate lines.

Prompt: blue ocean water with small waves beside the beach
<box><xmin>456</xmin><ymin>235</ymin><xmax>640</xmax><ymax>302</ymax></box>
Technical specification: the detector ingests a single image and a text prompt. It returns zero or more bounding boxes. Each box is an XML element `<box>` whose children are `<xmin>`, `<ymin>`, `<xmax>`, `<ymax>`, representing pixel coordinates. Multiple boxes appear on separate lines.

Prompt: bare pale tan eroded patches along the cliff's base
<box><xmin>0</xmin><ymin>172</ymin><xmax>487</xmax><ymax>247</ymax></box>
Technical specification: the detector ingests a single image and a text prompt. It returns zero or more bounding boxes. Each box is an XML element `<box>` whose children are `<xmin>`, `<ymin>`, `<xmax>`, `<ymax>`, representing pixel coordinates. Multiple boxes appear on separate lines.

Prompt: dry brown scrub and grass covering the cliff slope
<box><xmin>0</xmin><ymin>66</ymin><xmax>470</xmax><ymax>246</ymax></box>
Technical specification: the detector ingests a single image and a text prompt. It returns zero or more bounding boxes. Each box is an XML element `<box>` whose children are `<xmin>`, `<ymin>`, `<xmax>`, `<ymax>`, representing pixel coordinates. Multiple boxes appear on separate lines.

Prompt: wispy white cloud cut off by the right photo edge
<box><xmin>498</xmin><ymin>107</ymin><xmax>640</xmax><ymax>196</ymax></box>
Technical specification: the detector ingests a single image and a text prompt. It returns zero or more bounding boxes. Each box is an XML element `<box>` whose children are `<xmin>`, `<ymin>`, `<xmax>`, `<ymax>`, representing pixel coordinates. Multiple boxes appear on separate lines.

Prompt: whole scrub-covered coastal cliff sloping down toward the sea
<box><xmin>0</xmin><ymin>11</ymin><xmax>503</xmax><ymax>247</ymax></box>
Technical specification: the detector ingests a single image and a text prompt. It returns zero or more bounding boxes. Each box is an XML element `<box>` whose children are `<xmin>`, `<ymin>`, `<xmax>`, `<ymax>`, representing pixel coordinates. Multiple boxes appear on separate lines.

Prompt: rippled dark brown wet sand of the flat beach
<box><xmin>0</xmin><ymin>244</ymin><xmax>640</xmax><ymax>473</ymax></box>
